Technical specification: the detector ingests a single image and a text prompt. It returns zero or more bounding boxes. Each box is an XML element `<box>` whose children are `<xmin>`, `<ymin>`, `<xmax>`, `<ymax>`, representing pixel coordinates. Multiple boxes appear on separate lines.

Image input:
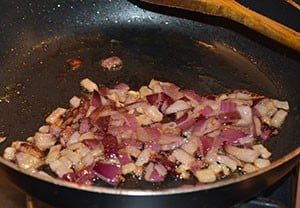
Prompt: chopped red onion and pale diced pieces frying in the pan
<box><xmin>4</xmin><ymin>77</ymin><xmax>289</xmax><ymax>186</ymax></box>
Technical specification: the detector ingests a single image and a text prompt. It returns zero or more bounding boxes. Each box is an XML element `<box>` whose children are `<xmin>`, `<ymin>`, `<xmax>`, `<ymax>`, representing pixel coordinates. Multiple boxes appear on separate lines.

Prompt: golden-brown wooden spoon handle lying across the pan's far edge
<box><xmin>141</xmin><ymin>0</ymin><xmax>300</xmax><ymax>51</ymax></box>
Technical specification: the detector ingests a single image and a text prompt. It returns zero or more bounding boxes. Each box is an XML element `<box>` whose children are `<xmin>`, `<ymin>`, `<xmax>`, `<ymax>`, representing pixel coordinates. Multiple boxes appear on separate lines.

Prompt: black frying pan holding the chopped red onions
<box><xmin>0</xmin><ymin>0</ymin><xmax>300</xmax><ymax>207</ymax></box>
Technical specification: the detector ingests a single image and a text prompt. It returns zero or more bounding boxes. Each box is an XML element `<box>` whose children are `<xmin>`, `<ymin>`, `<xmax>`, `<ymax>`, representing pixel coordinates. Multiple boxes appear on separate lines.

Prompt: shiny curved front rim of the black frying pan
<box><xmin>0</xmin><ymin>147</ymin><xmax>300</xmax><ymax>197</ymax></box>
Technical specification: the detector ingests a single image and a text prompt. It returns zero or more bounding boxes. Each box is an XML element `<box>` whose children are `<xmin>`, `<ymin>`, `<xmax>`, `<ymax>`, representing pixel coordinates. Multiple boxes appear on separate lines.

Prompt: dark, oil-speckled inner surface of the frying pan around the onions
<box><xmin>0</xmin><ymin>1</ymin><xmax>300</xmax><ymax>192</ymax></box>
